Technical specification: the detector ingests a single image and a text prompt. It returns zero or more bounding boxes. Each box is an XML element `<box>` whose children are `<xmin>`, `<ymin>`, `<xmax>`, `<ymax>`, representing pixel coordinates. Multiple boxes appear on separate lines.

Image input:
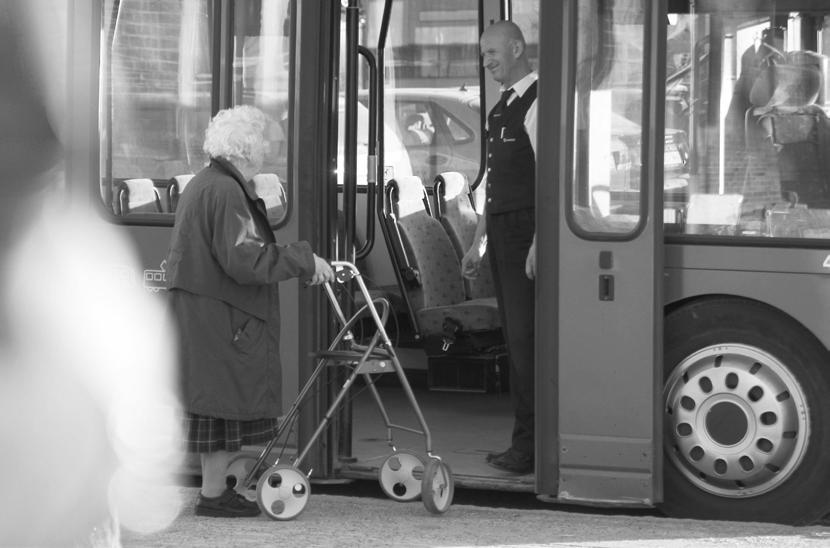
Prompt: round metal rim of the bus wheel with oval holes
<box><xmin>664</xmin><ymin>344</ymin><xmax>809</xmax><ymax>497</ymax></box>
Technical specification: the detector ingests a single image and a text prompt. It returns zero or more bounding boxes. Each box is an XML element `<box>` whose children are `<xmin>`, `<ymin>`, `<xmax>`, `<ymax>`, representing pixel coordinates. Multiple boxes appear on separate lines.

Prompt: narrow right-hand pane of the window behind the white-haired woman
<box><xmin>233</xmin><ymin>0</ymin><xmax>291</xmax><ymax>225</ymax></box>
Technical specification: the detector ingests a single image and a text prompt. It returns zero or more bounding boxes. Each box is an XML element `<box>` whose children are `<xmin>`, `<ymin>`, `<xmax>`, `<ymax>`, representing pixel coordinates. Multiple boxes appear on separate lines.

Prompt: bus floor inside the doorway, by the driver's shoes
<box><xmin>338</xmin><ymin>360</ymin><xmax>534</xmax><ymax>492</ymax></box>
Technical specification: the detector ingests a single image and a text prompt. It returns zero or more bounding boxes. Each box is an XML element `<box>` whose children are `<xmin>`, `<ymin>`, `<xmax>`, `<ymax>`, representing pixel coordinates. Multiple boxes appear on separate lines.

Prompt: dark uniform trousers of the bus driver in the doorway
<box><xmin>487</xmin><ymin>209</ymin><xmax>536</xmax><ymax>458</ymax></box>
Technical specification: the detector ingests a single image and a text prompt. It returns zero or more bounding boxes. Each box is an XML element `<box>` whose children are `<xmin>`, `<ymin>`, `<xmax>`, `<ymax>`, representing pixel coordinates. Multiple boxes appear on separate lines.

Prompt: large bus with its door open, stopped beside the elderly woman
<box><xmin>57</xmin><ymin>0</ymin><xmax>830</xmax><ymax>524</ymax></box>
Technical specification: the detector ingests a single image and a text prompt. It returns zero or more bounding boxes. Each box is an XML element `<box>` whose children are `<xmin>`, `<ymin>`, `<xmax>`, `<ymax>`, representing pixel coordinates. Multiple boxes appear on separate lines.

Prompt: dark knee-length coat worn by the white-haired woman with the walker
<box><xmin>167</xmin><ymin>159</ymin><xmax>314</xmax><ymax>420</ymax></box>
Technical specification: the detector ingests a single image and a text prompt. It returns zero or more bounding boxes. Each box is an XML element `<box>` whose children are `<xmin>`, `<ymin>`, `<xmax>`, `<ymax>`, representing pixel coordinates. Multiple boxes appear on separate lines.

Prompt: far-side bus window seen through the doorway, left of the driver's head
<box><xmin>361</xmin><ymin>0</ymin><xmax>482</xmax><ymax>187</ymax></box>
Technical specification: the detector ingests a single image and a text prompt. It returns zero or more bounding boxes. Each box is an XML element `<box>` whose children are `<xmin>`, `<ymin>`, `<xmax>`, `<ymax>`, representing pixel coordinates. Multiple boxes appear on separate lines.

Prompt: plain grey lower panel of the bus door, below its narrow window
<box><xmin>556</xmin><ymin>232</ymin><xmax>660</xmax><ymax>504</ymax></box>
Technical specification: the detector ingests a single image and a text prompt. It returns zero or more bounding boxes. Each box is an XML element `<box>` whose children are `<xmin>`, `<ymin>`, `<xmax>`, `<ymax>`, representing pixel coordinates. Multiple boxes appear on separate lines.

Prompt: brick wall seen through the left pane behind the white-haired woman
<box><xmin>105</xmin><ymin>0</ymin><xmax>210</xmax><ymax>179</ymax></box>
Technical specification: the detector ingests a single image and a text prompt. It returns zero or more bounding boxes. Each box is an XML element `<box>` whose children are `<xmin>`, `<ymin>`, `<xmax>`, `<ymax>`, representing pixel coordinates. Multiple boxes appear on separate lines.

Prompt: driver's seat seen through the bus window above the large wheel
<box><xmin>751</xmin><ymin>51</ymin><xmax>830</xmax><ymax>208</ymax></box>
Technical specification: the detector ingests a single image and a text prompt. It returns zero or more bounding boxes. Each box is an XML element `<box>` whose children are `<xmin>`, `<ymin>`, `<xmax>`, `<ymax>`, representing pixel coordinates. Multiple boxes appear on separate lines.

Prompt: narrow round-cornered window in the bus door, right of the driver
<box><xmin>571</xmin><ymin>0</ymin><xmax>645</xmax><ymax>233</ymax></box>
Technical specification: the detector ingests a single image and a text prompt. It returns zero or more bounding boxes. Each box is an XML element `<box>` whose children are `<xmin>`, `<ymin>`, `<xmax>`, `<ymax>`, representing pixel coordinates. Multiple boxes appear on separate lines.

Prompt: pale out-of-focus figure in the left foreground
<box><xmin>0</xmin><ymin>0</ymin><xmax>181</xmax><ymax>546</ymax></box>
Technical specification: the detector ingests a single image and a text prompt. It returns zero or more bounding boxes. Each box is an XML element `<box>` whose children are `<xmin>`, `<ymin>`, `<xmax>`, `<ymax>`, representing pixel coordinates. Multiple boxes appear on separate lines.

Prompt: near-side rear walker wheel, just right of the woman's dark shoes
<box><xmin>256</xmin><ymin>464</ymin><xmax>311</xmax><ymax>521</ymax></box>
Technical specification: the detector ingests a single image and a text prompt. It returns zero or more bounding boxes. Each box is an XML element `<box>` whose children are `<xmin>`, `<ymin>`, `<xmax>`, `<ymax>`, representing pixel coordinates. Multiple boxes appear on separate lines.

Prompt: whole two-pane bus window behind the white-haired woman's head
<box><xmin>101</xmin><ymin>0</ymin><xmax>291</xmax><ymax>225</ymax></box>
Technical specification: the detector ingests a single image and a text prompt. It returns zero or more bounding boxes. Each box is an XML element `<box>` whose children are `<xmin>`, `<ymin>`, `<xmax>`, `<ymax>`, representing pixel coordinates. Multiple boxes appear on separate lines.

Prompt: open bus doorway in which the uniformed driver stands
<box><xmin>328</xmin><ymin>0</ymin><xmax>538</xmax><ymax>492</ymax></box>
